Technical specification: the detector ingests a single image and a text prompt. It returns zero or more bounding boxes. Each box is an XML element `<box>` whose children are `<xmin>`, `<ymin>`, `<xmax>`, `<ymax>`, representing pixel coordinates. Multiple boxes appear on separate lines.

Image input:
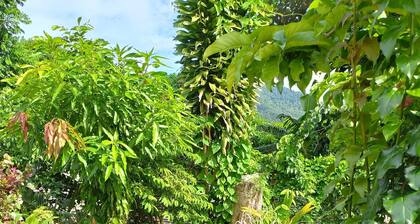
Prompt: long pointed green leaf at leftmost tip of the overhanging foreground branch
<box><xmin>203</xmin><ymin>32</ymin><xmax>251</xmax><ymax>58</ymax></box>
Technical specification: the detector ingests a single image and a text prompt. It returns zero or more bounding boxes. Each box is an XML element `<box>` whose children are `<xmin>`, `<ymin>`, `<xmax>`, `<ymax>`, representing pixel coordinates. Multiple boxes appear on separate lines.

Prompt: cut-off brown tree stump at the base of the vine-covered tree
<box><xmin>232</xmin><ymin>174</ymin><xmax>263</xmax><ymax>224</ymax></box>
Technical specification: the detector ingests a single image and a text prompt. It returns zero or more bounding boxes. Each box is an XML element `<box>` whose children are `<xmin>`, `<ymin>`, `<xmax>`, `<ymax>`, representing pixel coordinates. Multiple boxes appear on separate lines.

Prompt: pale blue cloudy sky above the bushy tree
<box><xmin>23</xmin><ymin>0</ymin><xmax>180</xmax><ymax>72</ymax></box>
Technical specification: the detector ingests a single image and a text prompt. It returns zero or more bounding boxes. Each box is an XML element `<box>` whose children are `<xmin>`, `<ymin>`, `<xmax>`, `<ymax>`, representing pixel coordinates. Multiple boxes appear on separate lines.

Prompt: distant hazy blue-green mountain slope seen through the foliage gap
<box><xmin>257</xmin><ymin>87</ymin><xmax>304</xmax><ymax>121</ymax></box>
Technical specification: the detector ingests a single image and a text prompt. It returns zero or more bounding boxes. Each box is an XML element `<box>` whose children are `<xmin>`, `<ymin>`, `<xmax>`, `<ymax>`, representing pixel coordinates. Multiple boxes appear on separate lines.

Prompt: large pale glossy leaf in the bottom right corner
<box><xmin>384</xmin><ymin>192</ymin><xmax>420</xmax><ymax>224</ymax></box>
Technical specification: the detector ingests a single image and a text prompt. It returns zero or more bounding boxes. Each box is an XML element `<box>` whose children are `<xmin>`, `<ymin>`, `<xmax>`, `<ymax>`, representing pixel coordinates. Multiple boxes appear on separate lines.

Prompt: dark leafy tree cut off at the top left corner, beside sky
<box><xmin>0</xmin><ymin>0</ymin><xmax>29</xmax><ymax>79</ymax></box>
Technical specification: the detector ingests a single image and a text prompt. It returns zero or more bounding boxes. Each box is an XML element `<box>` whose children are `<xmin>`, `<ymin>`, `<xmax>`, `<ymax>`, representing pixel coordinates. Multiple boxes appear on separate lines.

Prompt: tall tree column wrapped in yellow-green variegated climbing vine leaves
<box><xmin>175</xmin><ymin>0</ymin><xmax>272</xmax><ymax>220</ymax></box>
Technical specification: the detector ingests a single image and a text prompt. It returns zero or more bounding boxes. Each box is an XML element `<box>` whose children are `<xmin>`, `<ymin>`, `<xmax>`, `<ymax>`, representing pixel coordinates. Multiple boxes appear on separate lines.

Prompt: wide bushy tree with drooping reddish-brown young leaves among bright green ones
<box><xmin>0</xmin><ymin>19</ymin><xmax>212</xmax><ymax>223</ymax></box>
